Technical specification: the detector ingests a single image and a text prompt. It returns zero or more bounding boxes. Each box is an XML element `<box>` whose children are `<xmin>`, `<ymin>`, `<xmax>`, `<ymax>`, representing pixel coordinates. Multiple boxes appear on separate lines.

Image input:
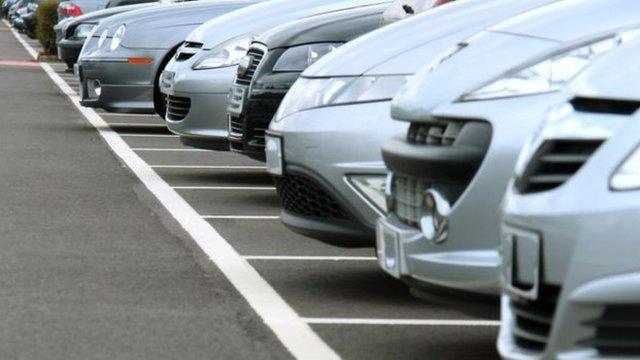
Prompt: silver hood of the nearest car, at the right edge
<box><xmin>569</xmin><ymin>41</ymin><xmax>640</xmax><ymax>101</ymax></box>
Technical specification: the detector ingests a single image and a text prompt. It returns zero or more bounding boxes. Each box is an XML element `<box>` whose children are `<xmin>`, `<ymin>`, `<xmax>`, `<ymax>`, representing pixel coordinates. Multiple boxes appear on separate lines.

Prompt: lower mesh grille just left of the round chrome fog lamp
<box><xmin>392</xmin><ymin>175</ymin><xmax>430</xmax><ymax>226</ymax></box>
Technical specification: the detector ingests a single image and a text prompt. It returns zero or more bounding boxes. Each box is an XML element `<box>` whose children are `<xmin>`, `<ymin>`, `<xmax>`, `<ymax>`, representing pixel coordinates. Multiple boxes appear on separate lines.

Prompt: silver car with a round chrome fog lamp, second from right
<box><xmin>377</xmin><ymin>0</ymin><xmax>640</xmax><ymax>296</ymax></box>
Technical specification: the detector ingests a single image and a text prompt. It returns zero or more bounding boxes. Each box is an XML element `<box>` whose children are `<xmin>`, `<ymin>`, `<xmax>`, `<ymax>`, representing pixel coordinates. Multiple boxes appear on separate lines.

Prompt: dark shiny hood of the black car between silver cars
<box><xmin>256</xmin><ymin>4</ymin><xmax>388</xmax><ymax>49</ymax></box>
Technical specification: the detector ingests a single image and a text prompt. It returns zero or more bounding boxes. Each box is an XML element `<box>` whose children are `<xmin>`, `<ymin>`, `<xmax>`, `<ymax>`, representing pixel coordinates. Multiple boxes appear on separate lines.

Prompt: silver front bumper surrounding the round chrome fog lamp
<box><xmin>378</xmin><ymin>94</ymin><xmax>565</xmax><ymax>296</ymax></box>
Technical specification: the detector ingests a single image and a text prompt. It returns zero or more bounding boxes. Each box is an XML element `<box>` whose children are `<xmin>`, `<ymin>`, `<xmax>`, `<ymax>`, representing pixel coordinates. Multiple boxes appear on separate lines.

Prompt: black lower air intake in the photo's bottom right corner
<box><xmin>578</xmin><ymin>305</ymin><xmax>640</xmax><ymax>357</ymax></box>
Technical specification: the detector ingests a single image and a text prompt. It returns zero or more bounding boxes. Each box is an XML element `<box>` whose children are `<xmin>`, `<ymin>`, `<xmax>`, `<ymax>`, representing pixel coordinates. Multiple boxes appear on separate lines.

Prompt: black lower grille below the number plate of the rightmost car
<box><xmin>510</xmin><ymin>285</ymin><xmax>560</xmax><ymax>352</ymax></box>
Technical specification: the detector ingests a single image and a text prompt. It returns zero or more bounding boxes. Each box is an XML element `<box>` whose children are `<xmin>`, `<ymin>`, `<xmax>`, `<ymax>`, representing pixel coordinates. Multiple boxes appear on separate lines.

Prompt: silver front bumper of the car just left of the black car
<box><xmin>160</xmin><ymin>56</ymin><xmax>236</xmax><ymax>150</ymax></box>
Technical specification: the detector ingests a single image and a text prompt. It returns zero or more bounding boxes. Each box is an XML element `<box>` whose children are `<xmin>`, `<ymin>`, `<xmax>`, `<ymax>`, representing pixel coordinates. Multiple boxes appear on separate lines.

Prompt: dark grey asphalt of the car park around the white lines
<box><xmin>0</xmin><ymin>24</ymin><xmax>498</xmax><ymax>359</ymax></box>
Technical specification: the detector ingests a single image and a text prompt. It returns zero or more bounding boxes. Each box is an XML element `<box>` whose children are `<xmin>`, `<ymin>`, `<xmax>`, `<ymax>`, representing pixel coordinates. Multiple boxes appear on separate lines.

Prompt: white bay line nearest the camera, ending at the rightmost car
<box><xmin>302</xmin><ymin>318</ymin><xmax>500</xmax><ymax>326</ymax></box>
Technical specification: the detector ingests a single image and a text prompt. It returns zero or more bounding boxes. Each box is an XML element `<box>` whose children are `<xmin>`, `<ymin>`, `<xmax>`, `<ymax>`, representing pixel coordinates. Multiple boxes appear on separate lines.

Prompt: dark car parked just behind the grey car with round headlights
<box><xmin>53</xmin><ymin>1</ymin><xmax>160</xmax><ymax>69</ymax></box>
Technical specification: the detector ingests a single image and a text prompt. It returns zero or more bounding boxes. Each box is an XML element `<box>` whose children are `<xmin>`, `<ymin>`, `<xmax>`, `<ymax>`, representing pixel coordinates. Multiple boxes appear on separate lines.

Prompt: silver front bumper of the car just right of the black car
<box><xmin>268</xmin><ymin>102</ymin><xmax>406</xmax><ymax>246</ymax></box>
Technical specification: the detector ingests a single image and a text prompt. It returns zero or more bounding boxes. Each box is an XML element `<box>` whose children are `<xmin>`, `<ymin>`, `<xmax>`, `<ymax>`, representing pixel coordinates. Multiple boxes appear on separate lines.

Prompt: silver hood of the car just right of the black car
<box><xmin>303</xmin><ymin>0</ymin><xmax>554</xmax><ymax>77</ymax></box>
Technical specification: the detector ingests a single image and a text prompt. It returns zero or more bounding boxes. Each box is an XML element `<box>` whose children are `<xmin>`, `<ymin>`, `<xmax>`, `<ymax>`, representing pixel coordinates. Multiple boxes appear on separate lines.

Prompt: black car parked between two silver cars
<box><xmin>227</xmin><ymin>0</ymin><xmax>390</xmax><ymax>161</ymax></box>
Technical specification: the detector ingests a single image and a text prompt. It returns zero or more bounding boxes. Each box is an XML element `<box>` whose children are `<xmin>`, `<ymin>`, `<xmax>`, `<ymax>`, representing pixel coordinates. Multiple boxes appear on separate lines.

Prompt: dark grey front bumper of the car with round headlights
<box><xmin>78</xmin><ymin>49</ymin><xmax>166</xmax><ymax>114</ymax></box>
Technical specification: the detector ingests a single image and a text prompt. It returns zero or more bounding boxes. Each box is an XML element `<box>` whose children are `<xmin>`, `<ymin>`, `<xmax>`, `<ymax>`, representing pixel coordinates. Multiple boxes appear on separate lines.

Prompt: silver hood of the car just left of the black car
<box><xmin>187</xmin><ymin>0</ymin><xmax>386</xmax><ymax>50</ymax></box>
